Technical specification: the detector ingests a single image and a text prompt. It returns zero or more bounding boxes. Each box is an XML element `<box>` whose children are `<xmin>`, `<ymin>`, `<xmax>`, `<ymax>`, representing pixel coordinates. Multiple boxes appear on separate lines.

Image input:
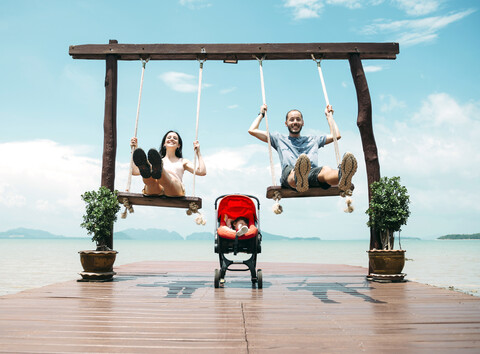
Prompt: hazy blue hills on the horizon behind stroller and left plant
<box><xmin>0</xmin><ymin>228</ymin><xmax>320</xmax><ymax>241</ymax></box>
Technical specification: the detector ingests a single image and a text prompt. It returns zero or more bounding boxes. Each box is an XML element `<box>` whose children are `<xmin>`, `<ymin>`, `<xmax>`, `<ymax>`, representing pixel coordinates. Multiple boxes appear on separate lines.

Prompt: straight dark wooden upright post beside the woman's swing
<box><xmin>101</xmin><ymin>40</ymin><xmax>118</xmax><ymax>249</ymax></box>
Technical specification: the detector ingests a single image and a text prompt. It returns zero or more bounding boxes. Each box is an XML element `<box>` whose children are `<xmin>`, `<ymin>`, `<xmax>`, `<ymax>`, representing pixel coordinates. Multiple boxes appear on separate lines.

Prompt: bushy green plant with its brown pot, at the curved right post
<box><xmin>366</xmin><ymin>177</ymin><xmax>410</xmax><ymax>281</ymax></box>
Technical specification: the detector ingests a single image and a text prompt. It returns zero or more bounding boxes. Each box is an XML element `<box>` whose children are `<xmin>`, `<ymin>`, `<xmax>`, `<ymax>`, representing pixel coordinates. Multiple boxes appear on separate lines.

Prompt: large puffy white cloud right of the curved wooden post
<box><xmin>375</xmin><ymin>93</ymin><xmax>480</xmax><ymax>215</ymax></box>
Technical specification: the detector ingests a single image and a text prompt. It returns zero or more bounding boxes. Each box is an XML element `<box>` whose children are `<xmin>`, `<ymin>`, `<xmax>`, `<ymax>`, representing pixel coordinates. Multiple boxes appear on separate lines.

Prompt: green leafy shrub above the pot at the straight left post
<box><xmin>80</xmin><ymin>187</ymin><xmax>120</xmax><ymax>250</ymax></box>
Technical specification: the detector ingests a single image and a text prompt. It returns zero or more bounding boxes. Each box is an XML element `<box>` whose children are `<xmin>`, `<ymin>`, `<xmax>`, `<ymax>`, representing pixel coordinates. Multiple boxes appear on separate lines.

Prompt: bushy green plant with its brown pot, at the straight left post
<box><xmin>78</xmin><ymin>187</ymin><xmax>120</xmax><ymax>281</ymax></box>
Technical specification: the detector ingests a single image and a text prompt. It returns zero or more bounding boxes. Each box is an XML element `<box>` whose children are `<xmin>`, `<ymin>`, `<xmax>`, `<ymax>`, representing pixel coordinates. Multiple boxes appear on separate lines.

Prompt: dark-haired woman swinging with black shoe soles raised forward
<box><xmin>130</xmin><ymin>130</ymin><xmax>207</xmax><ymax>197</ymax></box>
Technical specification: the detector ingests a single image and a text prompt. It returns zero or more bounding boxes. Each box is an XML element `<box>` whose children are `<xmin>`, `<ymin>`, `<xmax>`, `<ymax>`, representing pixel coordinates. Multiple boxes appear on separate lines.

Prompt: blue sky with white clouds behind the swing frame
<box><xmin>0</xmin><ymin>0</ymin><xmax>480</xmax><ymax>240</ymax></box>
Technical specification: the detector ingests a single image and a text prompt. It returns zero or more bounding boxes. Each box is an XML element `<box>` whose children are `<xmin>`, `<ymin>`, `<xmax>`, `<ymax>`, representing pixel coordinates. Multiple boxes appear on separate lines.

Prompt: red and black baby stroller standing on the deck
<box><xmin>214</xmin><ymin>194</ymin><xmax>263</xmax><ymax>289</ymax></box>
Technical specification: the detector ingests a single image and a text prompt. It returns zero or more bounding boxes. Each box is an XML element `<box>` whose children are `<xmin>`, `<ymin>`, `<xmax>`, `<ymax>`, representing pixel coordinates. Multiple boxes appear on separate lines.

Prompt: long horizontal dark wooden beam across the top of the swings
<box><xmin>69</xmin><ymin>42</ymin><xmax>399</xmax><ymax>60</ymax></box>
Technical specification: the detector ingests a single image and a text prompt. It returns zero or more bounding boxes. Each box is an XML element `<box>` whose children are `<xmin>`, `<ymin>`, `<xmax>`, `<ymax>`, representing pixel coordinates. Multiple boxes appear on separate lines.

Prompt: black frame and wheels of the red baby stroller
<box><xmin>214</xmin><ymin>194</ymin><xmax>263</xmax><ymax>289</ymax></box>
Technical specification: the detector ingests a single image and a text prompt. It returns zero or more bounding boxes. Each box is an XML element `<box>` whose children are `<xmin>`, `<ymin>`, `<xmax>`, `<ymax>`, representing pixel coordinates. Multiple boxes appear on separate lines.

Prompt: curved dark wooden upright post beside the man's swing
<box><xmin>348</xmin><ymin>54</ymin><xmax>381</xmax><ymax>262</ymax></box>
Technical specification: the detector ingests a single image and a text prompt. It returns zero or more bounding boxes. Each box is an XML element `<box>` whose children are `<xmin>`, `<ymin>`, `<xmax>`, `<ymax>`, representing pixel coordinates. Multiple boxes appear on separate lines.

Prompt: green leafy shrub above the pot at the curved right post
<box><xmin>366</xmin><ymin>177</ymin><xmax>410</xmax><ymax>249</ymax></box>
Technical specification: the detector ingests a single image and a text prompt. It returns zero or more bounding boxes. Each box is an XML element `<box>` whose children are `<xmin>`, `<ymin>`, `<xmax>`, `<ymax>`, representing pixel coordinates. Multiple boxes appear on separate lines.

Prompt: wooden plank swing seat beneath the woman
<box><xmin>117</xmin><ymin>192</ymin><xmax>202</xmax><ymax>209</ymax></box>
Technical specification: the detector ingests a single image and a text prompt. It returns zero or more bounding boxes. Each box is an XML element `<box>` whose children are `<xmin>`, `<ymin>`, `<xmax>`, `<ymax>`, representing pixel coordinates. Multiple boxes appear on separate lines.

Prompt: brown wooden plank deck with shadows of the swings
<box><xmin>0</xmin><ymin>262</ymin><xmax>480</xmax><ymax>353</ymax></box>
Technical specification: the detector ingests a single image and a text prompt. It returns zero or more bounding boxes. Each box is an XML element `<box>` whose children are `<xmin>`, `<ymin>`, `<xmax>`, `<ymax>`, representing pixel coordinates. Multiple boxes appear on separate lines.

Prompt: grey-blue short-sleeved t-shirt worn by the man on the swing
<box><xmin>270</xmin><ymin>132</ymin><xmax>327</xmax><ymax>170</ymax></box>
